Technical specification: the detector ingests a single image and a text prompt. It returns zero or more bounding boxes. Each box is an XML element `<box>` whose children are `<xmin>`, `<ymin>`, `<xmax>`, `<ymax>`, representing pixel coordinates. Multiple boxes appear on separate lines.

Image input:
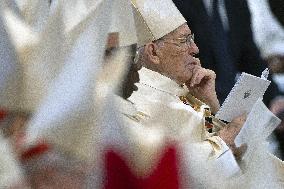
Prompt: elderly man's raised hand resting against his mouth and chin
<box><xmin>186</xmin><ymin>66</ymin><xmax>220</xmax><ymax>113</ymax></box>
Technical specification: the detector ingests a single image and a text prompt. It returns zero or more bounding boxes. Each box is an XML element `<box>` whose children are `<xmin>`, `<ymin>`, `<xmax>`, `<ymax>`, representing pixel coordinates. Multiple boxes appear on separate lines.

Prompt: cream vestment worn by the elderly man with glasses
<box><xmin>129</xmin><ymin>68</ymin><xmax>240</xmax><ymax>188</ymax></box>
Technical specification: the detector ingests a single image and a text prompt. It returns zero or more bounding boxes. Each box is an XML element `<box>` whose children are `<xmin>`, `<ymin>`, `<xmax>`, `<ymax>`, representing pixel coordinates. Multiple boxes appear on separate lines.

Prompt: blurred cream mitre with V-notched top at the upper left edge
<box><xmin>0</xmin><ymin>1</ymin><xmax>65</xmax><ymax>112</ymax></box>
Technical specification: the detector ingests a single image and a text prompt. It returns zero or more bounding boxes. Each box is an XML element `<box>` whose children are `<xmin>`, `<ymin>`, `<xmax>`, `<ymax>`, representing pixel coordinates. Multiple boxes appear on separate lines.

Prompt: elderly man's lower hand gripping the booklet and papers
<box><xmin>218</xmin><ymin>115</ymin><xmax>247</xmax><ymax>159</ymax></box>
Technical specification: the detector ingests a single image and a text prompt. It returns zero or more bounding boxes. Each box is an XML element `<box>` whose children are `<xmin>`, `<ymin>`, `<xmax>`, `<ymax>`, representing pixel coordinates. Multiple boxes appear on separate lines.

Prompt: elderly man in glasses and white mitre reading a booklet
<box><xmin>112</xmin><ymin>0</ymin><xmax>284</xmax><ymax>188</ymax></box>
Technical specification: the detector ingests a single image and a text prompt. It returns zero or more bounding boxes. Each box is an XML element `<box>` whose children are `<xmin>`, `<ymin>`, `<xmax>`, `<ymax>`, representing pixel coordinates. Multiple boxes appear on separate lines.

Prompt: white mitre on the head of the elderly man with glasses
<box><xmin>131</xmin><ymin>0</ymin><xmax>186</xmax><ymax>46</ymax></box>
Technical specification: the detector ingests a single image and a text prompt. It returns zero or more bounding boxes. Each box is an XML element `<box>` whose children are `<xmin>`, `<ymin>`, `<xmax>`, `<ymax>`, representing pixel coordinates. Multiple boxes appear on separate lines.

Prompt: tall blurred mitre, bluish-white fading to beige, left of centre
<box><xmin>24</xmin><ymin>0</ymin><xmax>112</xmax><ymax>160</ymax></box>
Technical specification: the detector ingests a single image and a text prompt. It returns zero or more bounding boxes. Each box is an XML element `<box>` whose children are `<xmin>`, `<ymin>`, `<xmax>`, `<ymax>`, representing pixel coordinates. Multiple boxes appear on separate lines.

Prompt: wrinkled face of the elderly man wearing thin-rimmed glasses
<box><xmin>156</xmin><ymin>24</ymin><xmax>200</xmax><ymax>83</ymax></box>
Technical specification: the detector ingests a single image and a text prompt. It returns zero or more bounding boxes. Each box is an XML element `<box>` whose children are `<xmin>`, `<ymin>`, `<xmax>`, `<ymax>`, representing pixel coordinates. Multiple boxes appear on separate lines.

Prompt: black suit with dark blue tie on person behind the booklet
<box><xmin>173</xmin><ymin>0</ymin><xmax>281</xmax><ymax>106</ymax></box>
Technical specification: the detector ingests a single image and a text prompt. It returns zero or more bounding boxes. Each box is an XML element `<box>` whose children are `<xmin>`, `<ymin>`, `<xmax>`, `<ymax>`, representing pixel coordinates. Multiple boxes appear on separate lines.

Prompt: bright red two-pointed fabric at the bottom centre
<box><xmin>104</xmin><ymin>147</ymin><xmax>179</xmax><ymax>189</ymax></box>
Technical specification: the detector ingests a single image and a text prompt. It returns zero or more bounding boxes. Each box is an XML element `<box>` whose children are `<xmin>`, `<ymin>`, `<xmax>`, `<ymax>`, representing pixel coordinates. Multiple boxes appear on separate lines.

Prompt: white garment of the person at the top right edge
<box><xmin>248</xmin><ymin>0</ymin><xmax>284</xmax><ymax>58</ymax></box>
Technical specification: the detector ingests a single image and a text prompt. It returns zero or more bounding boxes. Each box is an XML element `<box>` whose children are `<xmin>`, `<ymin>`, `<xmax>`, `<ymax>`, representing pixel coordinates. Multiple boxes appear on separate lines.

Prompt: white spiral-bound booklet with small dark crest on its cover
<box><xmin>215</xmin><ymin>69</ymin><xmax>271</xmax><ymax>122</ymax></box>
